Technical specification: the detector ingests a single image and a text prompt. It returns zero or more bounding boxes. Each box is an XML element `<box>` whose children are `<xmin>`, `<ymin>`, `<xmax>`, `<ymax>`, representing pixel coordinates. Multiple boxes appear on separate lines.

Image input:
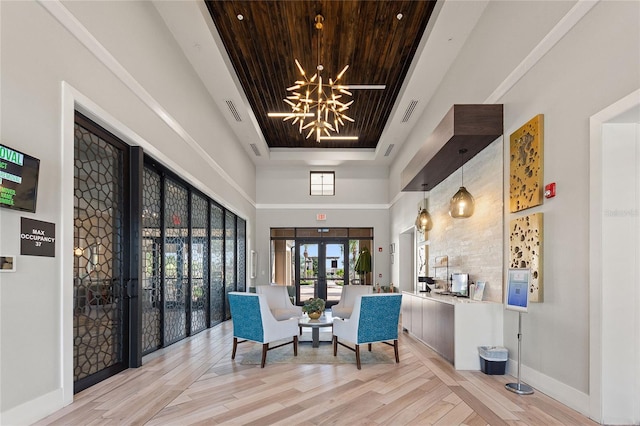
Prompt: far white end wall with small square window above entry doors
<box><xmin>256</xmin><ymin>166</ymin><xmax>393</xmax><ymax>285</ymax></box>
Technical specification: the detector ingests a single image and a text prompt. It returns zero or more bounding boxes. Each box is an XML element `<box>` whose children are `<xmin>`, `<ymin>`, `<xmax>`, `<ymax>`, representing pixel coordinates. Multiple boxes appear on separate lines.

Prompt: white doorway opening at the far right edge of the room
<box><xmin>589</xmin><ymin>90</ymin><xmax>640</xmax><ymax>424</ymax></box>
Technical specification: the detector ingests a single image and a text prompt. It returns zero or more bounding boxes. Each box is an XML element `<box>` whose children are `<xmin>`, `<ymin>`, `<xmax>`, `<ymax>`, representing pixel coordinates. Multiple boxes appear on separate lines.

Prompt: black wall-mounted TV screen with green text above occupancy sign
<box><xmin>0</xmin><ymin>144</ymin><xmax>40</xmax><ymax>213</ymax></box>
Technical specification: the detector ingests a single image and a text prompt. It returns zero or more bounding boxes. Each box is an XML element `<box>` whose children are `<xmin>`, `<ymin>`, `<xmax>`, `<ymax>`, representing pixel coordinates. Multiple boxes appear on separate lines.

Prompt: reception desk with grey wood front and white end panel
<box><xmin>402</xmin><ymin>291</ymin><xmax>503</xmax><ymax>370</ymax></box>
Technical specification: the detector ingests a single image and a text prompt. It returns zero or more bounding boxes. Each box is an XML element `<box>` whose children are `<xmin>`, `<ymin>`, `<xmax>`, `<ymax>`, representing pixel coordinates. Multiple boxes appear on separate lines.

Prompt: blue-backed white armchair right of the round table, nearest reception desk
<box><xmin>333</xmin><ymin>293</ymin><xmax>402</xmax><ymax>370</ymax></box>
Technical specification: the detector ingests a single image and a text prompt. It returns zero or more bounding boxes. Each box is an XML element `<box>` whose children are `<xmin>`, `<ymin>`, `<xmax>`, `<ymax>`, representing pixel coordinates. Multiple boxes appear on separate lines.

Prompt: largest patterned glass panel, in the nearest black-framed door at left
<box><xmin>73</xmin><ymin>123</ymin><xmax>124</xmax><ymax>381</ymax></box>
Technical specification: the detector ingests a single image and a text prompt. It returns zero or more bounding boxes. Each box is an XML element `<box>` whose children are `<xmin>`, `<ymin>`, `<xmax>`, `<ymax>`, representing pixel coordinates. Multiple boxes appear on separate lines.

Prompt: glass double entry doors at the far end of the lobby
<box><xmin>296</xmin><ymin>239</ymin><xmax>349</xmax><ymax>307</ymax></box>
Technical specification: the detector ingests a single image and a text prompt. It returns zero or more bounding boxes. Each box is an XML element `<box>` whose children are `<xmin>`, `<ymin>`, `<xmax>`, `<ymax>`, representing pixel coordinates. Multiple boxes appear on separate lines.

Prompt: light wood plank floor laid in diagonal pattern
<box><xmin>37</xmin><ymin>321</ymin><xmax>595</xmax><ymax>426</ymax></box>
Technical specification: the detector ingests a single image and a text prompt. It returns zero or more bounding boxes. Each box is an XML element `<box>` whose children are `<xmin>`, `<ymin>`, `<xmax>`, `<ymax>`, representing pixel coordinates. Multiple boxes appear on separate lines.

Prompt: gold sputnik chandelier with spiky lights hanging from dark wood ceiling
<box><xmin>269</xmin><ymin>15</ymin><xmax>358</xmax><ymax>142</ymax></box>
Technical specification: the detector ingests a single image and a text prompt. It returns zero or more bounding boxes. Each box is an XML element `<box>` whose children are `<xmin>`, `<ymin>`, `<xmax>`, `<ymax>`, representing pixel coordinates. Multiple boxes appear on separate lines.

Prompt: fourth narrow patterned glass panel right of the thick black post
<box><xmin>209</xmin><ymin>204</ymin><xmax>226</xmax><ymax>326</ymax></box>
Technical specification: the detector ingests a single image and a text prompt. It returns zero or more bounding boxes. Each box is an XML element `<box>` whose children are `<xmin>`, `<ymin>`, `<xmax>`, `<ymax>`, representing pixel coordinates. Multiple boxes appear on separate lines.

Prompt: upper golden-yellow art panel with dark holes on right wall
<box><xmin>509</xmin><ymin>114</ymin><xmax>544</xmax><ymax>213</ymax></box>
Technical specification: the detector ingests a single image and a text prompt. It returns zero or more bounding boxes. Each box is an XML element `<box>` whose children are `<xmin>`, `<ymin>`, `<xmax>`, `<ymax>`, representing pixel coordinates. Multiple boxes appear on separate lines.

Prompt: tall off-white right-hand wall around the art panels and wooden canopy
<box><xmin>390</xmin><ymin>1</ymin><xmax>640</xmax><ymax>420</ymax></box>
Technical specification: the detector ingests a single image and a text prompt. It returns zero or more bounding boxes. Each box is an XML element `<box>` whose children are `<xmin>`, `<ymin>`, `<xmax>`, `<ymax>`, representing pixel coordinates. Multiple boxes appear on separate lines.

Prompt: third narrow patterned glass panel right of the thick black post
<box><xmin>191</xmin><ymin>194</ymin><xmax>209</xmax><ymax>334</ymax></box>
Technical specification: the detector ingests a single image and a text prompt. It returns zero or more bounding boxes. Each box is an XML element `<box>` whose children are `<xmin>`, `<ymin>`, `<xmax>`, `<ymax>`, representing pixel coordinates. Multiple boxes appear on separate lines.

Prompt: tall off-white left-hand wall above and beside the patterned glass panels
<box><xmin>0</xmin><ymin>1</ymin><xmax>256</xmax><ymax>424</ymax></box>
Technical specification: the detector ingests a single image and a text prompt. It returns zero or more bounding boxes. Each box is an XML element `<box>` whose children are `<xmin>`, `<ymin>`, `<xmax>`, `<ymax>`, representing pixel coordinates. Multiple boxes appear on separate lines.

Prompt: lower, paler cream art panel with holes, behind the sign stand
<box><xmin>509</xmin><ymin>213</ymin><xmax>543</xmax><ymax>302</ymax></box>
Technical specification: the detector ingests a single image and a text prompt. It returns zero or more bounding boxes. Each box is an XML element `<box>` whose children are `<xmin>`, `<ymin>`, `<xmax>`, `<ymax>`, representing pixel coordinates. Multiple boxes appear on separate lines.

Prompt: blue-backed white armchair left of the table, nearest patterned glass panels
<box><xmin>229</xmin><ymin>292</ymin><xmax>298</xmax><ymax>368</ymax></box>
